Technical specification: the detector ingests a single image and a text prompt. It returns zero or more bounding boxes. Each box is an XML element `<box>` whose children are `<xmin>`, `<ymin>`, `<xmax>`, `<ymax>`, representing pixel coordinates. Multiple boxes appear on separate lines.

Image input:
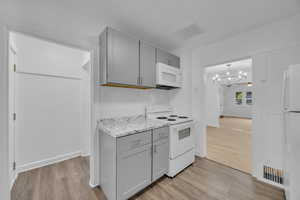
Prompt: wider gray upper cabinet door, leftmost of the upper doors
<box><xmin>107</xmin><ymin>28</ymin><xmax>139</xmax><ymax>85</ymax></box>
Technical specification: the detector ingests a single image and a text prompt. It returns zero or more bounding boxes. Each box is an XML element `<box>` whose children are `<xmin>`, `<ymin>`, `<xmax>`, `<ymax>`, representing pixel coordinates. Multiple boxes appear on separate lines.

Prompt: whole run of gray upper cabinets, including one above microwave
<box><xmin>95</xmin><ymin>27</ymin><xmax>180</xmax><ymax>88</ymax></box>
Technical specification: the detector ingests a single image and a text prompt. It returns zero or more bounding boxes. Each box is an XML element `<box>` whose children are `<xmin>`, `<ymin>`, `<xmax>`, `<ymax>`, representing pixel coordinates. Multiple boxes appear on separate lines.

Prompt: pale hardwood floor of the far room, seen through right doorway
<box><xmin>207</xmin><ymin>117</ymin><xmax>252</xmax><ymax>173</ymax></box>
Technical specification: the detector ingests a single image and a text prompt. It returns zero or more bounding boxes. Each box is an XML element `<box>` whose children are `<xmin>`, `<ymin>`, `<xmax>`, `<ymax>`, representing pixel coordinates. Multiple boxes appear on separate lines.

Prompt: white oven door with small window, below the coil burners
<box><xmin>170</xmin><ymin>122</ymin><xmax>195</xmax><ymax>159</ymax></box>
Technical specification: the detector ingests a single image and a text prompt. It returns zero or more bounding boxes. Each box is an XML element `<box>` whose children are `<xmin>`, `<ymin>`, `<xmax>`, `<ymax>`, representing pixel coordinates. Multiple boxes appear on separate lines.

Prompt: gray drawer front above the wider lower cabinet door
<box><xmin>117</xmin><ymin>131</ymin><xmax>151</xmax><ymax>153</ymax></box>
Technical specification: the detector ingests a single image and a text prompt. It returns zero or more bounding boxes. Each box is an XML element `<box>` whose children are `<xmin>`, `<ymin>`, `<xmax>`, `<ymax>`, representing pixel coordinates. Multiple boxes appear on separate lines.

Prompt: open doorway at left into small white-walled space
<box><xmin>8</xmin><ymin>32</ymin><xmax>91</xmax><ymax>197</ymax></box>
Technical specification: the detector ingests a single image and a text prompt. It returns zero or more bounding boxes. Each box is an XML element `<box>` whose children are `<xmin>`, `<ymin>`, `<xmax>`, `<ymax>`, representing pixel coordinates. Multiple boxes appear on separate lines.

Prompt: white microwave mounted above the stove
<box><xmin>156</xmin><ymin>63</ymin><xmax>182</xmax><ymax>88</ymax></box>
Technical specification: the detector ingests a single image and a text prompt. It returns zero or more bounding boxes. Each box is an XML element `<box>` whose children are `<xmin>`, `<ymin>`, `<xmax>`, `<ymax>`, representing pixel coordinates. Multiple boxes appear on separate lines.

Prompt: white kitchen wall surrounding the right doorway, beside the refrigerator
<box><xmin>192</xmin><ymin>12</ymin><xmax>300</xmax><ymax>184</ymax></box>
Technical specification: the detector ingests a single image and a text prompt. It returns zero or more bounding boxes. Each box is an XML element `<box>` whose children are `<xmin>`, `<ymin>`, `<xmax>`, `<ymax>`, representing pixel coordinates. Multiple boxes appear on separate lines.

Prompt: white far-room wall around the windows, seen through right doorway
<box><xmin>222</xmin><ymin>85</ymin><xmax>253</xmax><ymax>118</ymax></box>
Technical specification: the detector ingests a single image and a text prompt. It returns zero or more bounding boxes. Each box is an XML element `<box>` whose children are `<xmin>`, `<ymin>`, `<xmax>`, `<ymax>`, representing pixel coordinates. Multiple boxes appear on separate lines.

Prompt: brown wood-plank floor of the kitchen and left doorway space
<box><xmin>11</xmin><ymin>157</ymin><xmax>283</xmax><ymax>200</ymax></box>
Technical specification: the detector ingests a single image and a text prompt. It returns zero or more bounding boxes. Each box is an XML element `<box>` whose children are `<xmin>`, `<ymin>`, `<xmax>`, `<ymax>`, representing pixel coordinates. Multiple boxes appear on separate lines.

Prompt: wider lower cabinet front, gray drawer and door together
<box><xmin>117</xmin><ymin>132</ymin><xmax>152</xmax><ymax>200</ymax></box>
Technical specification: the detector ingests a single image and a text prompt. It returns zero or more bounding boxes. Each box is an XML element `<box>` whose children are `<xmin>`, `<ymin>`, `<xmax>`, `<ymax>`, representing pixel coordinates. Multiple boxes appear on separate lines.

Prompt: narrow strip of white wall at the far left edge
<box><xmin>0</xmin><ymin>24</ymin><xmax>10</xmax><ymax>200</ymax></box>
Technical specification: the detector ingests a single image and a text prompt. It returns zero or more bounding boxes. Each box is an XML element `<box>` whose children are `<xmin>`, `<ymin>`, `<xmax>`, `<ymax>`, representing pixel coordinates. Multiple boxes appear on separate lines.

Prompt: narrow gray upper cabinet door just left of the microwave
<box><xmin>140</xmin><ymin>41</ymin><xmax>156</xmax><ymax>87</ymax></box>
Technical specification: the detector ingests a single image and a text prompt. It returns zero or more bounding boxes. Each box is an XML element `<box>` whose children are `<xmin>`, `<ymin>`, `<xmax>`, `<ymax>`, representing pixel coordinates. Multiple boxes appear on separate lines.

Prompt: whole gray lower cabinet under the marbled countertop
<box><xmin>100</xmin><ymin>127</ymin><xmax>169</xmax><ymax>200</ymax></box>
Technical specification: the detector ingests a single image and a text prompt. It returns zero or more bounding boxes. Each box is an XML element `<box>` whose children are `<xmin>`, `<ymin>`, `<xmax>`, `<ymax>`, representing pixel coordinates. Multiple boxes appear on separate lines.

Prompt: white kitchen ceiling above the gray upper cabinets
<box><xmin>0</xmin><ymin>0</ymin><xmax>300</xmax><ymax>50</ymax></box>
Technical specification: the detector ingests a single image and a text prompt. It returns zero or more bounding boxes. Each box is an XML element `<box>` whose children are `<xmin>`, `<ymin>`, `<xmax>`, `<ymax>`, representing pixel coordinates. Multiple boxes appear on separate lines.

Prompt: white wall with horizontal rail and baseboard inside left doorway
<box><xmin>11</xmin><ymin>33</ymin><xmax>89</xmax><ymax>171</ymax></box>
